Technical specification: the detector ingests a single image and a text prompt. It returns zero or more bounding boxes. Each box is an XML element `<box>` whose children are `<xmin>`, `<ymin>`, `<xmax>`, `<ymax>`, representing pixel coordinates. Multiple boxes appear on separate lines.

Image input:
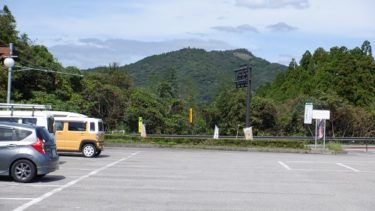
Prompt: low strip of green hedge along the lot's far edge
<box><xmin>106</xmin><ymin>135</ymin><xmax>307</xmax><ymax>149</ymax></box>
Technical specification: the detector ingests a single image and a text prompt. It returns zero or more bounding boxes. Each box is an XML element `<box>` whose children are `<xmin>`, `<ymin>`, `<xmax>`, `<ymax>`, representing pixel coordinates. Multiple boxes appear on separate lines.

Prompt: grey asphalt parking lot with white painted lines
<box><xmin>0</xmin><ymin>147</ymin><xmax>375</xmax><ymax>211</ymax></box>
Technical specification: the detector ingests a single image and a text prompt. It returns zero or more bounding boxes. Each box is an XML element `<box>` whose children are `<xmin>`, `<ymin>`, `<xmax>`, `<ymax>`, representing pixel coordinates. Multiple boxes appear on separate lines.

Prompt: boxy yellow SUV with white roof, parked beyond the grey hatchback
<box><xmin>55</xmin><ymin>116</ymin><xmax>104</xmax><ymax>157</ymax></box>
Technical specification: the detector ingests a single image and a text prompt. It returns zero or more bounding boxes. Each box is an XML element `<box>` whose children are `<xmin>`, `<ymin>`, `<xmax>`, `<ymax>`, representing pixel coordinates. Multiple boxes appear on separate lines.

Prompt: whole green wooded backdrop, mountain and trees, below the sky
<box><xmin>0</xmin><ymin>6</ymin><xmax>375</xmax><ymax>137</ymax></box>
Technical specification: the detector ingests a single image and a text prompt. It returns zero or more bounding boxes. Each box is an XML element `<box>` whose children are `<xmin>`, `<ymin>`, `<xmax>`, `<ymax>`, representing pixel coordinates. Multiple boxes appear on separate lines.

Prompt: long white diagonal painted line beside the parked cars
<box><xmin>13</xmin><ymin>151</ymin><xmax>139</xmax><ymax>211</ymax></box>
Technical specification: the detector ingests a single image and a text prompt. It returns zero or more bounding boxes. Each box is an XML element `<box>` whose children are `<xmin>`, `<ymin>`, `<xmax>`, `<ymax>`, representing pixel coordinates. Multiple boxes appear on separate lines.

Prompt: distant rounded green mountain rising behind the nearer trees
<box><xmin>89</xmin><ymin>48</ymin><xmax>286</xmax><ymax>102</ymax></box>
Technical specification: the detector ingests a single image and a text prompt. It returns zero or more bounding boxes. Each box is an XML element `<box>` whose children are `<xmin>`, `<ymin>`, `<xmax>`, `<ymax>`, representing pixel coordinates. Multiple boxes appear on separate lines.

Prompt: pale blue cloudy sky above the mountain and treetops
<box><xmin>0</xmin><ymin>0</ymin><xmax>375</xmax><ymax>68</ymax></box>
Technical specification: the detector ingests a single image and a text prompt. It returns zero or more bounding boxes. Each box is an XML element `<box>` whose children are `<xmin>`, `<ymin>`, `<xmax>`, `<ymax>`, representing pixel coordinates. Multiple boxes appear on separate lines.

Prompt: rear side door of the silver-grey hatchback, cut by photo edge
<box><xmin>0</xmin><ymin>126</ymin><xmax>19</xmax><ymax>175</ymax></box>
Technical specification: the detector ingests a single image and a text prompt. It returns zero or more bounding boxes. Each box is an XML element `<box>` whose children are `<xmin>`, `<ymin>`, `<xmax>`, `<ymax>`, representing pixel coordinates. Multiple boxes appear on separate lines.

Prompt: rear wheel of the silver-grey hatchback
<box><xmin>10</xmin><ymin>160</ymin><xmax>36</xmax><ymax>182</ymax></box>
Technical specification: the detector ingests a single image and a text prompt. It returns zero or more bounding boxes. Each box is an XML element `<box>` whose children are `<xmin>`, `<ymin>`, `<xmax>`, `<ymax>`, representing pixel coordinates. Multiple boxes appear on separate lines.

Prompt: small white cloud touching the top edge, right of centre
<box><xmin>236</xmin><ymin>0</ymin><xmax>309</xmax><ymax>9</ymax></box>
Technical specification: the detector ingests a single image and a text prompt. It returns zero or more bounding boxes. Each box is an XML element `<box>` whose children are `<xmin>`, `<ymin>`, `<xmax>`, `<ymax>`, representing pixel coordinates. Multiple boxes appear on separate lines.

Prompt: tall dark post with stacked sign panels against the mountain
<box><xmin>234</xmin><ymin>64</ymin><xmax>252</xmax><ymax>127</ymax></box>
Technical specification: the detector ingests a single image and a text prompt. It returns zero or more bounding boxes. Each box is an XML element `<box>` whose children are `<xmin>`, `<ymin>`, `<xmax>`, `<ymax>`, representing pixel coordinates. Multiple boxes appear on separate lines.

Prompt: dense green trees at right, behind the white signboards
<box><xmin>257</xmin><ymin>41</ymin><xmax>375</xmax><ymax>136</ymax></box>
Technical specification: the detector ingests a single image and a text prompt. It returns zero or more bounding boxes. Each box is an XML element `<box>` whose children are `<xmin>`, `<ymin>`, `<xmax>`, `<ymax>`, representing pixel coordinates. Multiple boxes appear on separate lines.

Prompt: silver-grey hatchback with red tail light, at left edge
<box><xmin>0</xmin><ymin>122</ymin><xmax>59</xmax><ymax>182</ymax></box>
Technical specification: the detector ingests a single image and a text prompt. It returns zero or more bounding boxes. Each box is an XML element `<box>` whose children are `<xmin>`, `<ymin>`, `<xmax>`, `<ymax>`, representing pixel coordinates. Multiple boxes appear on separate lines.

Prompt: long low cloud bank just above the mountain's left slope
<box><xmin>49</xmin><ymin>38</ymin><xmax>233</xmax><ymax>68</ymax></box>
